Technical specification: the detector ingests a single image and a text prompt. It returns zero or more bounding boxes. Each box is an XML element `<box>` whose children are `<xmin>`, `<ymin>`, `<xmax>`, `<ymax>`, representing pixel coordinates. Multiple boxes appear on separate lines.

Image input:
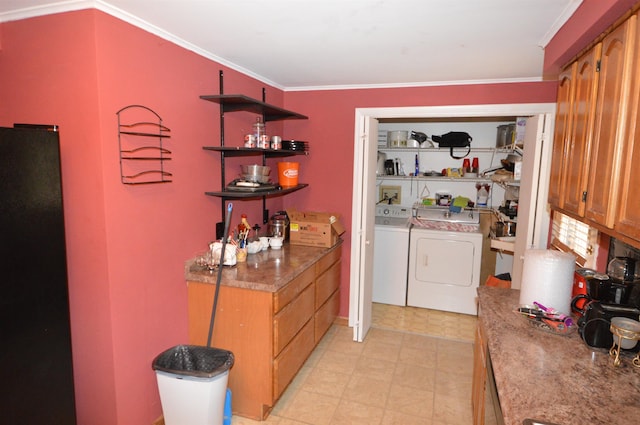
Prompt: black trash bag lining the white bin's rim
<box><xmin>152</xmin><ymin>345</ymin><xmax>235</xmax><ymax>378</ymax></box>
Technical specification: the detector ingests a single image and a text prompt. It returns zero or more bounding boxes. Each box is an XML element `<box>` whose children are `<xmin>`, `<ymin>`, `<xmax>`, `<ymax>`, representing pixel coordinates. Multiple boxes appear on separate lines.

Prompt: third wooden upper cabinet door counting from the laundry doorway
<box><xmin>585</xmin><ymin>16</ymin><xmax>636</xmax><ymax>228</ymax></box>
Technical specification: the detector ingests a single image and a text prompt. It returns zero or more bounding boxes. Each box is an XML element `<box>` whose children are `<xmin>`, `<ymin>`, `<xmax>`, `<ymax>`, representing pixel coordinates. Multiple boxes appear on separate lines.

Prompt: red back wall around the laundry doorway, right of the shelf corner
<box><xmin>283</xmin><ymin>82</ymin><xmax>556</xmax><ymax>317</ymax></box>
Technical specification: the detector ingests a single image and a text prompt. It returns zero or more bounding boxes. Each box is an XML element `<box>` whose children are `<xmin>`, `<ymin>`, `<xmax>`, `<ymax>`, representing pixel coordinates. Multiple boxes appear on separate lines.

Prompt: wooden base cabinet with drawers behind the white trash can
<box><xmin>187</xmin><ymin>246</ymin><xmax>342</xmax><ymax>420</ymax></box>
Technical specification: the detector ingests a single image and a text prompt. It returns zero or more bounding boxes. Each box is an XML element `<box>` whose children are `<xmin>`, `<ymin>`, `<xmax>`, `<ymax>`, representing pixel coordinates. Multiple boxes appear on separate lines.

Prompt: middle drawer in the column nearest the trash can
<box><xmin>273</xmin><ymin>285</ymin><xmax>315</xmax><ymax>356</ymax></box>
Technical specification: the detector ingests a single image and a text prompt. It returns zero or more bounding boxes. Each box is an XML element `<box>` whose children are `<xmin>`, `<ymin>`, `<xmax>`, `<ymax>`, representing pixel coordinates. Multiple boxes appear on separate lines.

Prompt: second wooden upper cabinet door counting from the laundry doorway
<box><xmin>562</xmin><ymin>44</ymin><xmax>602</xmax><ymax>216</ymax></box>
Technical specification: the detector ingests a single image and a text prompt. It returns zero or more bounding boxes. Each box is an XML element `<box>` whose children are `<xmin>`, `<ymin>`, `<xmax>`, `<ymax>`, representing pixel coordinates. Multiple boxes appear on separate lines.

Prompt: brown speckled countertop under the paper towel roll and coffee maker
<box><xmin>478</xmin><ymin>286</ymin><xmax>640</xmax><ymax>425</ymax></box>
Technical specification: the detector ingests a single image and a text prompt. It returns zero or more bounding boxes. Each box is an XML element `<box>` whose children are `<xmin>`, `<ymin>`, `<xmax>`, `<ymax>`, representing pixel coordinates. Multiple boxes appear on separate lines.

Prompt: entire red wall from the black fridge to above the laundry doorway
<box><xmin>0</xmin><ymin>4</ymin><xmax>616</xmax><ymax>425</ymax></box>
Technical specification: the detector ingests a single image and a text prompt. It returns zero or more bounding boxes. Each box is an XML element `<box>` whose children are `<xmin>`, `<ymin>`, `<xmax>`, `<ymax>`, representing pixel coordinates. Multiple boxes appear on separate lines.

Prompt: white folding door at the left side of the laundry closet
<box><xmin>349</xmin><ymin>116</ymin><xmax>378</xmax><ymax>342</ymax></box>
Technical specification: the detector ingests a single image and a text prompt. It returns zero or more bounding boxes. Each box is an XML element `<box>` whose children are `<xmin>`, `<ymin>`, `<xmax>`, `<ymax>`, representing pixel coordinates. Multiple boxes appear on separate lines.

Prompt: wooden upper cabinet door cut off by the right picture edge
<box><xmin>614</xmin><ymin>12</ymin><xmax>640</xmax><ymax>241</ymax></box>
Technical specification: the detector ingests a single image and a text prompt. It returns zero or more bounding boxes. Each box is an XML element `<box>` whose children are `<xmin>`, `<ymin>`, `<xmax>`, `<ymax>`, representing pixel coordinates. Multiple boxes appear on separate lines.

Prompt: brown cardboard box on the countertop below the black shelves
<box><xmin>287</xmin><ymin>209</ymin><xmax>345</xmax><ymax>248</ymax></box>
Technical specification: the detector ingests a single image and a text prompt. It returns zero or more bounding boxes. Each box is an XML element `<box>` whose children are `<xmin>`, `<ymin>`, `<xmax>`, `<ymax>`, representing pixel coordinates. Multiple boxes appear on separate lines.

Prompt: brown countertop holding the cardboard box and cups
<box><xmin>184</xmin><ymin>242</ymin><xmax>342</xmax><ymax>292</ymax></box>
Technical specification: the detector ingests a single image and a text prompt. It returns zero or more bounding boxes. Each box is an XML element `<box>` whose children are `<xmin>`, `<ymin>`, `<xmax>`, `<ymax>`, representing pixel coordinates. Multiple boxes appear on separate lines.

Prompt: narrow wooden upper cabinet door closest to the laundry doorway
<box><xmin>548</xmin><ymin>62</ymin><xmax>578</xmax><ymax>208</ymax></box>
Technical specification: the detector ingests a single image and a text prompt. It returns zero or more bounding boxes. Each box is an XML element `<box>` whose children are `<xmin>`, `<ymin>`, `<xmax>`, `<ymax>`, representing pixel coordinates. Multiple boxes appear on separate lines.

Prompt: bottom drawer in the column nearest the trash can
<box><xmin>273</xmin><ymin>320</ymin><xmax>315</xmax><ymax>404</ymax></box>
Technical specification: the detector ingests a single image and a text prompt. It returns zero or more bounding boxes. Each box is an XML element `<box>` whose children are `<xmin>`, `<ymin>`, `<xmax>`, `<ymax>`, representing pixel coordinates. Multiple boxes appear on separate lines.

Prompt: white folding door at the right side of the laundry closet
<box><xmin>511</xmin><ymin>114</ymin><xmax>553</xmax><ymax>289</ymax></box>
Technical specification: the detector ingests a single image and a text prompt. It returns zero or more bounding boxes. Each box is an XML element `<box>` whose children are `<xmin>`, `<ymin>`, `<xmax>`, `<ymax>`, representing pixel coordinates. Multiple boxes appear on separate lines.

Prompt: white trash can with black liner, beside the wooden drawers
<box><xmin>152</xmin><ymin>345</ymin><xmax>234</xmax><ymax>425</ymax></box>
